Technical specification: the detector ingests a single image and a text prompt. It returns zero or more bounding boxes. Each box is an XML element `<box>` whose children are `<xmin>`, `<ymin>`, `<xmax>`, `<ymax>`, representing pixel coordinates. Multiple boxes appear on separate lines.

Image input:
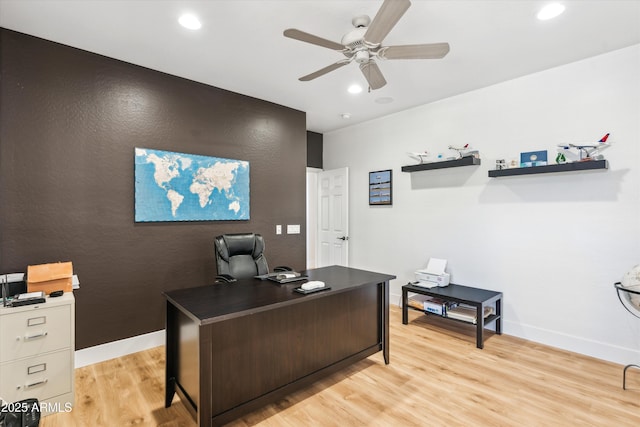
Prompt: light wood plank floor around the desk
<box><xmin>41</xmin><ymin>307</ymin><xmax>640</xmax><ymax>427</ymax></box>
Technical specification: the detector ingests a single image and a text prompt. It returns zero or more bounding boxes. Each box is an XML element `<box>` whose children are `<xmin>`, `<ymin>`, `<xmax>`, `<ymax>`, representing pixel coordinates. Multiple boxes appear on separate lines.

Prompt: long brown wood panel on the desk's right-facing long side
<box><xmin>207</xmin><ymin>285</ymin><xmax>381</xmax><ymax>416</ymax></box>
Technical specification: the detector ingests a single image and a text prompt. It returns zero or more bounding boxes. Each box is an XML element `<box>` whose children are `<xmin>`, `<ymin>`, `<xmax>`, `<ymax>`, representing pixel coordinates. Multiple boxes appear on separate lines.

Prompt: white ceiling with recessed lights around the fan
<box><xmin>0</xmin><ymin>0</ymin><xmax>640</xmax><ymax>133</ymax></box>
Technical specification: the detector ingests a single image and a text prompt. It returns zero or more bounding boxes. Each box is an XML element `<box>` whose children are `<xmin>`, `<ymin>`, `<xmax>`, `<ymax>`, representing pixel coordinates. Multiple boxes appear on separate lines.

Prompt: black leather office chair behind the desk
<box><xmin>214</xmin><ymin>233</ymin><xmax>291</xmax><ymax>282</ymax></box>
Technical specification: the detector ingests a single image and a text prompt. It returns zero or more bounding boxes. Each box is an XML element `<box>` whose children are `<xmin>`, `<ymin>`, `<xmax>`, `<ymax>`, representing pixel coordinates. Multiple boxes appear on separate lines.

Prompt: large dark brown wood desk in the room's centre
<box><xmin>164</xmin><ymin>266</ymin><xmax>395</xmax><ymax>426</ymax></box>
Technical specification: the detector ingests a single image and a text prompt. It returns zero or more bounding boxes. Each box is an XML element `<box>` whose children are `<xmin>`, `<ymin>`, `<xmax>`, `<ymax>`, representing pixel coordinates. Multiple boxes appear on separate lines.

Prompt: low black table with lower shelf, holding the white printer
<box><xmin>402</xmin><ymin>283</ymin><xmax>502</xmax><ymax>348</ymax></box>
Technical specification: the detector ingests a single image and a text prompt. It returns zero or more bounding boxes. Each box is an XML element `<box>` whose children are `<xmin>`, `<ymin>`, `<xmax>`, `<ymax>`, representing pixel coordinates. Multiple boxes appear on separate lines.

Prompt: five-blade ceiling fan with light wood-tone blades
<box><xmin>284</xmin><ymin>0</ymin><xmax>449</xmax><ymax>89</ymax></box>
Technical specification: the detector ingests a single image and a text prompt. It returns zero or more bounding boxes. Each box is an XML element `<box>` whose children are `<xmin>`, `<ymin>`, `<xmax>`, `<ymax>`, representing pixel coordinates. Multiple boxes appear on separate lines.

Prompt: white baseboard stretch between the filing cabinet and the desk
<box><xmin>75</xmin><ymin>329</ymin><xmax>165</xmax><ymax>368</ymax></box>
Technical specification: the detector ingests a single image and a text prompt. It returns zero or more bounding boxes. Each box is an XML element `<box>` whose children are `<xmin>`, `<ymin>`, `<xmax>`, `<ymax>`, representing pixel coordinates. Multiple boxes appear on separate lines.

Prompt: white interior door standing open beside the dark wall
<box><xmin>317</xmin><ymin>168</ymin><xmax>349</xmax><ymax>267</ymax></box>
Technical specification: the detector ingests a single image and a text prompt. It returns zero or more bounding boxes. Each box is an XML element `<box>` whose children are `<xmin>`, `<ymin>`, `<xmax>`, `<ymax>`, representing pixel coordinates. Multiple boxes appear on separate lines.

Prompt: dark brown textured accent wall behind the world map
<box><xmin>0</xmin><ymin>29</ymin><xmax>307</xmax><ymax>349</ymax></box>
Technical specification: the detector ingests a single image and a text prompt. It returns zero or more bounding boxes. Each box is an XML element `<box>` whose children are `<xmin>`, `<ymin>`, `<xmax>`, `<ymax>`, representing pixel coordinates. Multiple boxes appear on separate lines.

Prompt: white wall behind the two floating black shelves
<box><xmin>324</xmin><ymin>45</ymin><xmax>640</xmax><ymax>364</ymax></box>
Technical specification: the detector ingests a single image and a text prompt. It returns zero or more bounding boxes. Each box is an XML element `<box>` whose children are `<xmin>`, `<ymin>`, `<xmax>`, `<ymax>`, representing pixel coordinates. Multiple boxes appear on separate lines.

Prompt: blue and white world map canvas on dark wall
<box><xmin>135</xmin><ymin>148</ymin><xmax>249</xmax><ymax>222</ymax></box>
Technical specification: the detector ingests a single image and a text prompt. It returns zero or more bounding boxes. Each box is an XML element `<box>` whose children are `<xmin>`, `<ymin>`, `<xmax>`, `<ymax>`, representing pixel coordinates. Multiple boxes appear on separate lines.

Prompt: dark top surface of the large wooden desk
<box><xmin>164</xmin><ymin>266</ymin><xmax>396</xmax><ymax>324</ymax></box>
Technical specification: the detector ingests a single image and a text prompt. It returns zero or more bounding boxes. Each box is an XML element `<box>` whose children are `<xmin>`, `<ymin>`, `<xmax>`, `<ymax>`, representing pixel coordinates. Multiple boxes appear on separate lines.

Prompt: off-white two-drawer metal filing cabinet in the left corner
<box><xmin>0</xmin><ymin>292</ymin><xmax>75</xmax><ymax>415</ymax></box>
